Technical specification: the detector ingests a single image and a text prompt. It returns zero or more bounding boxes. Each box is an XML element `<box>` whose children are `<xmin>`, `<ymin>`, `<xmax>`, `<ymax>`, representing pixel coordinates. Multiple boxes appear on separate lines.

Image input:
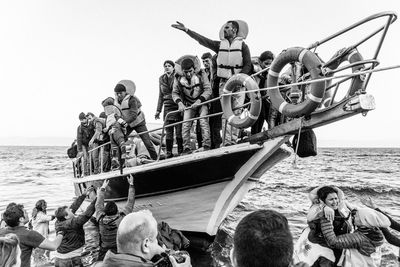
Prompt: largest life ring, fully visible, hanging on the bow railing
<box><xmin>267</xmin><ymin>47</ymin><xmax>326</xmax><ymax>118</ymax></box>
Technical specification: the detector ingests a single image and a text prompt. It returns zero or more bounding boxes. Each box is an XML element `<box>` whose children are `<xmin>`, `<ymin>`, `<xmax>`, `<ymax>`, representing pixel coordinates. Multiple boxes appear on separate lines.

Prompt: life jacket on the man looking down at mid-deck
<box><xmin>177</xmin><ymin>72</ymin><xmax>204</xmax><ymax>105</ymax></box>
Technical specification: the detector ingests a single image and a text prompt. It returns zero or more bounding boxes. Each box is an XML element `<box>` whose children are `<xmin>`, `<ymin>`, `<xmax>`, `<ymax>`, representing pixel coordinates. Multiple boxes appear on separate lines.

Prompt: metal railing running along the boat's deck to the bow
<box><xmin>74</xmin><ymin>12</ymin><xmax>397</xmax><ymax>180</ymax></box>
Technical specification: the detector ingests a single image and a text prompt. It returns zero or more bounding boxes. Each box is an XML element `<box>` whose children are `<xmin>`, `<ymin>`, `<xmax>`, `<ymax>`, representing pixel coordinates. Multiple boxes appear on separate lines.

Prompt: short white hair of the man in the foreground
<box><xmin>117</xmin><ymin>210</ymin><xmax>157</xmax><ymax>253</ymax></box>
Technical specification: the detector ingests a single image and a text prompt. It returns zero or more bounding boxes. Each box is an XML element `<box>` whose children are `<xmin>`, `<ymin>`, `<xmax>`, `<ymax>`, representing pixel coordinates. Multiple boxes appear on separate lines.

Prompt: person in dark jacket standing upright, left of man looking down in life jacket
<box><xmin>155</xmin><ymin>60</ymin><xmax>183</xmax><ymax>158</ymax></box>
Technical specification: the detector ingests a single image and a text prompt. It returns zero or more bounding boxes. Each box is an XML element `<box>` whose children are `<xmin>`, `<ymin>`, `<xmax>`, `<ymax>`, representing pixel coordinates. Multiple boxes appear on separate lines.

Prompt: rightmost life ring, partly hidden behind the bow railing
<box><xmin>327</xmin><ymin>49</ymin><xmax>365</xmax><ymax>96</ymax></box>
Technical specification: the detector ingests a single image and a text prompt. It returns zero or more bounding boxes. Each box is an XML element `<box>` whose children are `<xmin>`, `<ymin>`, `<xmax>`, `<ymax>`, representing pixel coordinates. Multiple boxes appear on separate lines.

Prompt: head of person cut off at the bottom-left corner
<box><xmin>0</xmin><ymin>234</ymin><xmax>21</xmax><ymax>267</ymax></box>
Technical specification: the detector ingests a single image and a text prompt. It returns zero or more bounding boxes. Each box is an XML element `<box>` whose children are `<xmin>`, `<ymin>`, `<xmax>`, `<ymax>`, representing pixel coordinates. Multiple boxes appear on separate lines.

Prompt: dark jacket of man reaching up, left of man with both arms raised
<box><xmin>55</xmin><ymin>195</ymin><xmax>96</xmax><ymax>254</ymax></box>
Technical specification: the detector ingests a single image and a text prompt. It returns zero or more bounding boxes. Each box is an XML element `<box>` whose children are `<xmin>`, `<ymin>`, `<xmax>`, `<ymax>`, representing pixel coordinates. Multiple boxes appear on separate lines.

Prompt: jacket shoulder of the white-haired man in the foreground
<box><xmin>103</xmin><ymin>251</ymin><xmax>154</xmax><ymax>267</ymax></box>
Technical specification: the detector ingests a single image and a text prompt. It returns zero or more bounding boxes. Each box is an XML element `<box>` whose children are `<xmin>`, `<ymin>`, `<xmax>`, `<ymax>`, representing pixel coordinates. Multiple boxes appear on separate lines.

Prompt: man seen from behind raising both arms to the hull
<box><xmin>96</xmin><ymin>175</ymin><xmax>135</xmax><ymax>261</ymax></box>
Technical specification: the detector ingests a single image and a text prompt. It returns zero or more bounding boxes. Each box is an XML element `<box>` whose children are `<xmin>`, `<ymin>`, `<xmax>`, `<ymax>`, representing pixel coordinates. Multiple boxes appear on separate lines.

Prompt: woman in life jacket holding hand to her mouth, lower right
<box><xmin>307</xmin><ymin>186</ymin><xmax>351</xmax><ymax>266</ymax></box>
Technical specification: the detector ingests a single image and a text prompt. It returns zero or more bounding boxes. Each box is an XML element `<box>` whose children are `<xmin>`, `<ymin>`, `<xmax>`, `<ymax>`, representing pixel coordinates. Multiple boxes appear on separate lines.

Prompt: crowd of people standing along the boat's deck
<box><xmin>68</xmin><ymin>21</ymin><xmax>300</xmax><ymax>176</ymax></box>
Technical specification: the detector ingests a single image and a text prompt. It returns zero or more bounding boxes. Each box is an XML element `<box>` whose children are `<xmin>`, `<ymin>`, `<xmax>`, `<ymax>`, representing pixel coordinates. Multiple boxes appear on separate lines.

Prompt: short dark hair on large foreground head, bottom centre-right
<box><xmin>233</xmin><ymin>210</ymin><xmax>293</xmax><ymax>267</ymax></box>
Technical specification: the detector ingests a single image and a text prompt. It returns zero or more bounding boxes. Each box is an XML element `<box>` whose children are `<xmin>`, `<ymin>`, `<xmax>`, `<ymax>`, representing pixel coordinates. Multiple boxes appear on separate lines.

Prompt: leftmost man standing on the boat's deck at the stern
<box><xmin>76</xmin><ymin>112</ymin><xmax>94</xmax><ymax>175</ymax></box>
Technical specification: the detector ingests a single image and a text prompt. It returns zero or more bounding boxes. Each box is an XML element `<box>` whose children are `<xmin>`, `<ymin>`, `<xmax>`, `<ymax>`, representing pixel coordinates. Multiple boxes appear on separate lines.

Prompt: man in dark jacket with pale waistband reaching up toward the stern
<box><xmin>55</xmin><ymin>187</ymin><xmax>96</xmax><ymax>267</ymax></box>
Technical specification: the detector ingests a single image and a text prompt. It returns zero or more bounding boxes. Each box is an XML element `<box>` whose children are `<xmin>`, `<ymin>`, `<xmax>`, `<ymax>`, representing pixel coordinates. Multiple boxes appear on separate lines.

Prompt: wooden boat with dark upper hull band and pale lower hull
<box><xmin>73</xmin><ymin>12</ymin><xmax>397</xmax><ymax>239</ymax></box>
